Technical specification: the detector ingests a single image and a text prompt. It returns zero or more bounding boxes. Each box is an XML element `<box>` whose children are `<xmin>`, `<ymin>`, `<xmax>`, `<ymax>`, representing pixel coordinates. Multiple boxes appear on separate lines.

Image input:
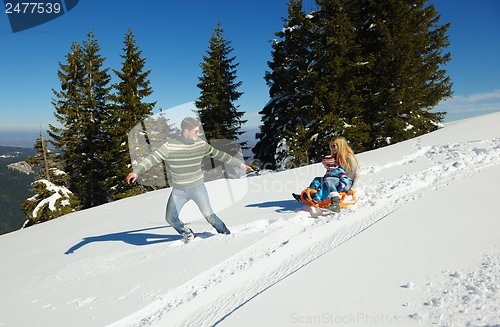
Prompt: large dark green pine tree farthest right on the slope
<box><xmin>356</xmin><ymin>0</ymin><xmax>452</xmax><ymax>150</ymax></box>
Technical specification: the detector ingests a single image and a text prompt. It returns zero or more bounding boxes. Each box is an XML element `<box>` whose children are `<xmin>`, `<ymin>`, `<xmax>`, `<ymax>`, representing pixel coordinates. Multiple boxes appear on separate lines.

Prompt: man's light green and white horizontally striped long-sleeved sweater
<box><xmin>134</xmin><ymin>136</ymin><xmax>241</xmax><ymax>189</ymax></box>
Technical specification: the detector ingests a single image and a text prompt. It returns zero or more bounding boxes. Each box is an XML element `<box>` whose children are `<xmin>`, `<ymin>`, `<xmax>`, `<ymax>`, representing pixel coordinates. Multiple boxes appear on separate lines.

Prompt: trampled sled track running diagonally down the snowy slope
<box><xmin>110</xmin><ymin>139</ymin><xmax>500</xmax><ymax>327</ymax></box>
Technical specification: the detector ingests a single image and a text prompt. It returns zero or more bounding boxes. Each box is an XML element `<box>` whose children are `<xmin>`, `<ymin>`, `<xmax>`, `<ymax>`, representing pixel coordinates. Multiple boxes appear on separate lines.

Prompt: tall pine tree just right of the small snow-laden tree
<box><xmin>49</xmin><ymin>31</ymin><xmax>110</xmax><ymax>208</ymax></box>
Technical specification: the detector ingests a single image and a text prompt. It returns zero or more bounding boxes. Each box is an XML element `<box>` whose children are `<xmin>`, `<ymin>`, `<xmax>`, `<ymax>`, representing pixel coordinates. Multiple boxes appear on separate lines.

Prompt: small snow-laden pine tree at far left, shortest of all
<box><xmin>21</xmin><ymin>129</ymin><xmax>80</xmax><ymax>228</ymax></box>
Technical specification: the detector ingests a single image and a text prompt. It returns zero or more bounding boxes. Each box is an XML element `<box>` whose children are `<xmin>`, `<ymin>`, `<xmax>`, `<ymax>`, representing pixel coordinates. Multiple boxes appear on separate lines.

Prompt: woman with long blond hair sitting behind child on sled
<box><xmin>324</xmin><ymin>136</ymin><xmax>359</xmax><ymax>212</ymax></box>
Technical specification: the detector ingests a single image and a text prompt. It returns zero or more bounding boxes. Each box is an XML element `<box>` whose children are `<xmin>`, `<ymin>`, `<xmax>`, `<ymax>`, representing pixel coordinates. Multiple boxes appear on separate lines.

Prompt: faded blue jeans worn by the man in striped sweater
<box><xmin>165</xmin><ymin>184</ymin><xmax>229</xmax><ymax>235</ymax></box>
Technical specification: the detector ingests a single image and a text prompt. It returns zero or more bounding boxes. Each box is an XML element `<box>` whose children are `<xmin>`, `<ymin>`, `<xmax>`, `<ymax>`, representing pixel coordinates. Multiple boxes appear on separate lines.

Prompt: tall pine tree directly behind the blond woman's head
<box><xmin>307</xmin><ymin>0</ymin><xmax>369</xmax><ymax>156</ymax></box>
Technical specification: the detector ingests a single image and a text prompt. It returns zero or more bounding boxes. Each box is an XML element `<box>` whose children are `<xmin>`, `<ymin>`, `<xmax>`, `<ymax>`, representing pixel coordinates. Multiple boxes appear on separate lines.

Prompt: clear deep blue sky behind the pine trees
<box><xmin>0</xmin><ymin>0</ymin><xmax>500</xmax><ymax>138</ymax></box>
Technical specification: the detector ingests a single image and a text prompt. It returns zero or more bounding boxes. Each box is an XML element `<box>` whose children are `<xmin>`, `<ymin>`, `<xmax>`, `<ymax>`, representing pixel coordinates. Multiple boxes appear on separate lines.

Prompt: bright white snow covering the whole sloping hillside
<box><xmin>0</xmin><ymin>113</ymin><xmax>500</xmax><ymax>327</ymax></box>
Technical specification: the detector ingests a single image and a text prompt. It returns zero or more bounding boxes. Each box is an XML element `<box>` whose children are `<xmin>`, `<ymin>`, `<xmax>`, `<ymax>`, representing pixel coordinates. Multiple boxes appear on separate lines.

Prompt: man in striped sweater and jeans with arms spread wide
<box><xmin>126</xmin><ymin>117</ymin><xmax>251</xmax><ymax>243</ymax></box>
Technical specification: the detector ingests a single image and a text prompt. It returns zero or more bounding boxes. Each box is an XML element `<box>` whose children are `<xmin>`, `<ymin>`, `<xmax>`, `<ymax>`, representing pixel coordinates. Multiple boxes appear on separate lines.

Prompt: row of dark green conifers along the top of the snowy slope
<box><xmin>13</xmin><ymin>0</ymin><xmax>452</xmax><ymax>226</ymax></box>
